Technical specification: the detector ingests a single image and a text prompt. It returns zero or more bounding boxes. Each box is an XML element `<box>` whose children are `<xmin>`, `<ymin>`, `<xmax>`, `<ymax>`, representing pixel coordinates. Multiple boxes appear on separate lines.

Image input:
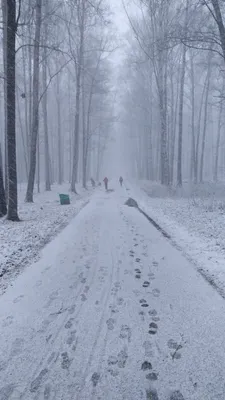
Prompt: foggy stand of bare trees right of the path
<box><xmin>121</xmin><ymin>0</ymin><xmax>225</xmax><ymax>186</ymax></box>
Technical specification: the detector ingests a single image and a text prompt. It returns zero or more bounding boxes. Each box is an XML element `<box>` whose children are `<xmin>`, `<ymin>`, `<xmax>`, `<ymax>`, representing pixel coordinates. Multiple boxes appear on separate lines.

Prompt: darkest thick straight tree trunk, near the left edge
<box><xmin>6</xmin><ymin>0</ymin><xmax>19</xmax><ymax>221</ymax></box>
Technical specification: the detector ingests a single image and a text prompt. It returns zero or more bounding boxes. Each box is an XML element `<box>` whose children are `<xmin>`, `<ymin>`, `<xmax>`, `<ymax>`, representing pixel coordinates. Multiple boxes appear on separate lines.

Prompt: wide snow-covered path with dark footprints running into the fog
<box><xmin>0</xmin><ymin>188</ymin><xmax>225</xmax><ymax>400</ymax></box>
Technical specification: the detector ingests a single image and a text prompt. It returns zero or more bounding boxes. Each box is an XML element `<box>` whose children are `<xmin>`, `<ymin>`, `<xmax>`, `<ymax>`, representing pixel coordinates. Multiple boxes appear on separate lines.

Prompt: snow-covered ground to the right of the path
<box><xmin>133</xmin><ymin>181</ymin><xmax>225</xmax><ymax>296</ymax></box>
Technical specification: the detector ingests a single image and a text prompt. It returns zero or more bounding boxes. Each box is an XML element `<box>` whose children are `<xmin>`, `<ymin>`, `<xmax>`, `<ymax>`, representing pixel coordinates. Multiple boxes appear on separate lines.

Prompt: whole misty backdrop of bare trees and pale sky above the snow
<box><xmin>0</xmin><ymin>0</ymin><xmax>225</xmax><ymax>219</ymax></box>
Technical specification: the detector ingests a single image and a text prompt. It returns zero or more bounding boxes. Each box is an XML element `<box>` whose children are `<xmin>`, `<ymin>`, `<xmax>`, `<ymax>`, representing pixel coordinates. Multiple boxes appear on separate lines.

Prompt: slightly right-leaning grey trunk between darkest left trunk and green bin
<box><xmin>26</xmin><ymin>0</ymin><xmax>42</xmax><ymax>203</ymax></box>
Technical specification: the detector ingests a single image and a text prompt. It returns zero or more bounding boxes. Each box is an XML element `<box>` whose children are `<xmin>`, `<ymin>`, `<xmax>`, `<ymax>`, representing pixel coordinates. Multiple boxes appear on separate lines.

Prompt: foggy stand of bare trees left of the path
<box><xmin>0</xmin><ymin>0</ymin><xmax>115</xmax><ymax>221</ymax></box>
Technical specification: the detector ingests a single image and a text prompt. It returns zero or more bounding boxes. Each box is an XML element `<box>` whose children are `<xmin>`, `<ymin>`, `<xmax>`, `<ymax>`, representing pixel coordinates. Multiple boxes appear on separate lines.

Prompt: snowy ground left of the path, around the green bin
<box><xmin>0</xmin><ymin>184</ymin><xmax>92</xmax><ymax>293</ymax></box>
